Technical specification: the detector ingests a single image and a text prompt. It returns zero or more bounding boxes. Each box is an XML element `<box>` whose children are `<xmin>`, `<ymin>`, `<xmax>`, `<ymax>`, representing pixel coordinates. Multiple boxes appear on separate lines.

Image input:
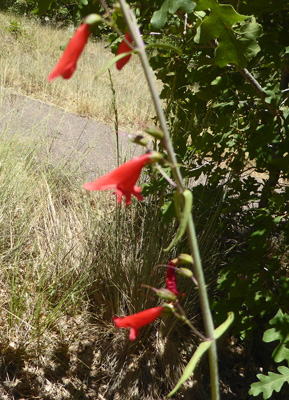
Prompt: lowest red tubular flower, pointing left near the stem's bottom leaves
<box><xmin>113</xmin><ymin>307</ymin><xmax>164</xmax><ymax>340</ymax></box>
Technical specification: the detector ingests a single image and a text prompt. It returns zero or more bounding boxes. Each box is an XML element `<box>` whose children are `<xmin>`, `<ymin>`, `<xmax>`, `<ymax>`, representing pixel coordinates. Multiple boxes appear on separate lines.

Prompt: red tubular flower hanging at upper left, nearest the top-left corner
<box><xmin>48</xmin><ymin>24</ymin><xmax>90</xmax><ymax>81</ymax></box>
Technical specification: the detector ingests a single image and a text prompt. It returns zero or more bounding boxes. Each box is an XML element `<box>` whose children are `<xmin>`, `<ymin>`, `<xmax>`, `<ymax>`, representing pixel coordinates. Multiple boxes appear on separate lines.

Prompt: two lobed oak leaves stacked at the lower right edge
<box><xmin>249</xmin><ymin>310</ymin><xmax>289</xmax><ymax>399</ymax></box>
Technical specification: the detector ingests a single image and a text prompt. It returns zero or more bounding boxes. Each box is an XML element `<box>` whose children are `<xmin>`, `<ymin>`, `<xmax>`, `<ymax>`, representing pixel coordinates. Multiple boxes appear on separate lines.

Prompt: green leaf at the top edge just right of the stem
<box><xmin>151</xmin><ymin>0</ymin><xmax>196</xmax><ymax>29</ymax></box>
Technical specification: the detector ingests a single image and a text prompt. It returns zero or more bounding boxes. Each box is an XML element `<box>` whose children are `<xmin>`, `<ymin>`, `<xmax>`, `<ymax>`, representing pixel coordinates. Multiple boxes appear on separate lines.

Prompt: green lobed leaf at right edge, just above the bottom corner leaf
<box><xmin>263</xmin><ymin>310</ymin><xmax>289</xmax><ymax>363</ymax></box>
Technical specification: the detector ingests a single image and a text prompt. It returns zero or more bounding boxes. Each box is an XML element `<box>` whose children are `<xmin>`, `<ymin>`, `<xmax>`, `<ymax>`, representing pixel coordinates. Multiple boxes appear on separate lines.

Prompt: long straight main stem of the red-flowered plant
<box><xmin>120</xmin><ymin>0</ymin><xmax>220</xmax><ymax>400</ymax></box>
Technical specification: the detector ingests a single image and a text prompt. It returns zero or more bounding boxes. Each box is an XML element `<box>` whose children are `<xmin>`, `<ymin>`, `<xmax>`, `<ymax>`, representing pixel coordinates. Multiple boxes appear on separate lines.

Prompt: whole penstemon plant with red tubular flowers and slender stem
<box><xmin>48</xmin><ymin>0</ymin><xmax>234</xmax><ymax>400</ymax></box>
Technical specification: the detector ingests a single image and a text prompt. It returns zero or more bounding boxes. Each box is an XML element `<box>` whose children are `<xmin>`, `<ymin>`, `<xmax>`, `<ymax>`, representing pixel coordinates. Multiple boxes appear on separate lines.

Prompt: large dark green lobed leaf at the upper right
<box><xmin>194</xmin><ymin>0</ymin><xmax>261</xmax><ymax>68</ymax></box>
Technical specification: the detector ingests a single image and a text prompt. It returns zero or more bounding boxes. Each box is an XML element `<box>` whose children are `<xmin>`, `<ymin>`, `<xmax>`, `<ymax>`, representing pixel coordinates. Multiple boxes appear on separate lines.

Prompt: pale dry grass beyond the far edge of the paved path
<box><xmin>0</xmin><ymin>13</ymin><xmax>154</xmax><ymax>129</ymax></box>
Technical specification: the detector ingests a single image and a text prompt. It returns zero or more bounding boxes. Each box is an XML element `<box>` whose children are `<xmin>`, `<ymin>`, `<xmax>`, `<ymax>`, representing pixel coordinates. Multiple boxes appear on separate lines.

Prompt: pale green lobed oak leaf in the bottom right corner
<box><xmin>249</xmin><ymin>366</ymin><xmax>289</xmax><ymax>400</ymax></box>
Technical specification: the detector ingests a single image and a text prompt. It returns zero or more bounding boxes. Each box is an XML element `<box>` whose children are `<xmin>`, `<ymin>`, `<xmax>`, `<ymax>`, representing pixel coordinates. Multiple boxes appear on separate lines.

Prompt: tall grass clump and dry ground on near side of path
<box><xmin>0</xmin><ymin>137</ymin><xmax>198</xmax><ymax>399</ymax></box>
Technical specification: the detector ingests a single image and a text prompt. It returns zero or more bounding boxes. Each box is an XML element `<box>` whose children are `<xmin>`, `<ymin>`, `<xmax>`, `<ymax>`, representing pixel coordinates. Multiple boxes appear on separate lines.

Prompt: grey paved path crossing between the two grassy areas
<box><xmin>0</xmin><ymin>90</ymin><xmax>140</xmax><ymax>179</ymax></box>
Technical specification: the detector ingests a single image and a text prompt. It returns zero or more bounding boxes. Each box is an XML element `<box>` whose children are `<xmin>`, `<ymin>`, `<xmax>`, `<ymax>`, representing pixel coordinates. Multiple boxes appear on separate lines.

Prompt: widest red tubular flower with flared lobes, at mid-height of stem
<box><xmin>83</xmin><ymin>153</ymin><xmax>154</xmax><ymax>206</ymax></box>
